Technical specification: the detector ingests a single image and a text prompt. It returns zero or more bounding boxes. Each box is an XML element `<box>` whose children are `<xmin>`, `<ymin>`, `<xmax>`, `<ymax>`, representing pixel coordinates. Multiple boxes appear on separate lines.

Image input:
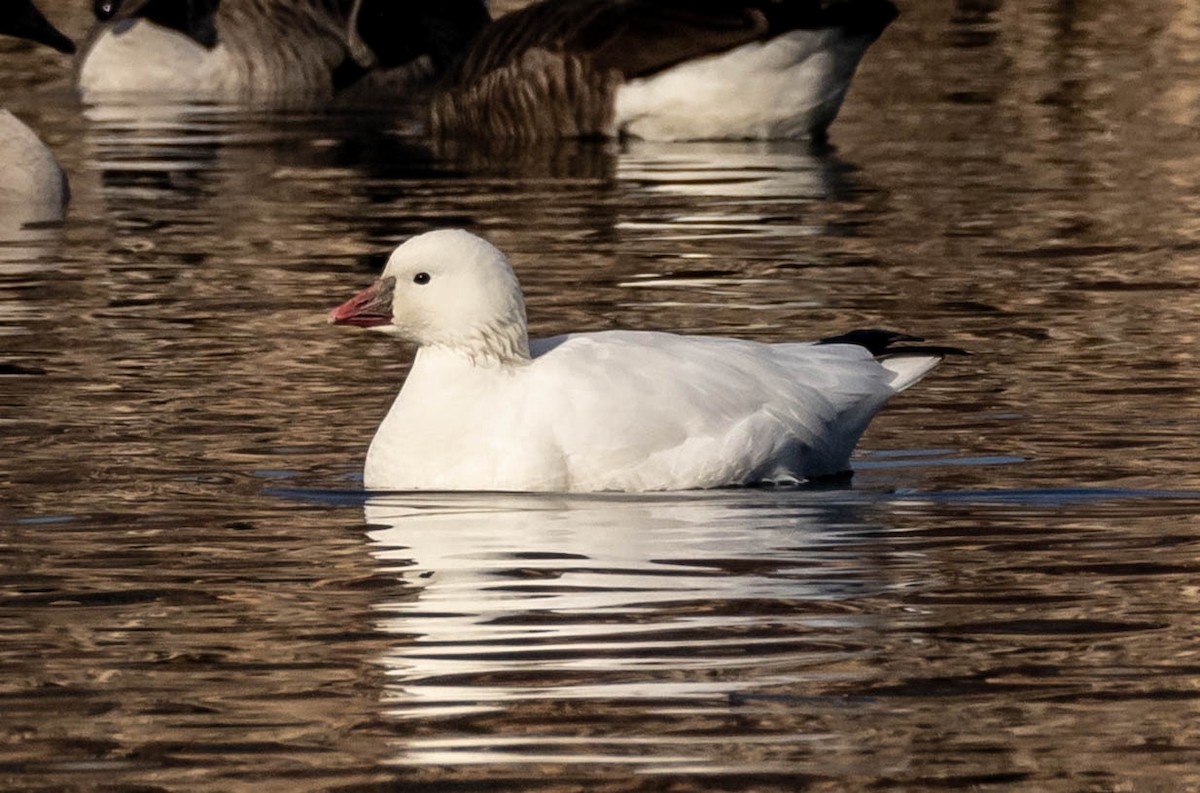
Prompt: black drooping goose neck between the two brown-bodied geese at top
<box><xmin>358</xmin><ymin>0</ymin><xmax>491</xmax><ymax>74</ymax></box>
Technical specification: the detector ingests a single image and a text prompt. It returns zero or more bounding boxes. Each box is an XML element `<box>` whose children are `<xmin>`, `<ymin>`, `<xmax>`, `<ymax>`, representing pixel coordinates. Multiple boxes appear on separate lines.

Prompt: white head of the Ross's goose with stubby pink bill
<box><xmin>330</xmin><ymin>229</ymin><xmax>529</xmax><ymax>362</ymax></box>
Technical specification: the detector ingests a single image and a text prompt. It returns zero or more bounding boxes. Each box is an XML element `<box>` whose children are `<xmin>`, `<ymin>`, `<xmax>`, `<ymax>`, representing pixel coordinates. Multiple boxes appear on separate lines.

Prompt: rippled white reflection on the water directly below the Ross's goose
<box><xmin>366</xmin><ymin>491</ymin><xmax>884</xmax><ymax>715</ymax></box>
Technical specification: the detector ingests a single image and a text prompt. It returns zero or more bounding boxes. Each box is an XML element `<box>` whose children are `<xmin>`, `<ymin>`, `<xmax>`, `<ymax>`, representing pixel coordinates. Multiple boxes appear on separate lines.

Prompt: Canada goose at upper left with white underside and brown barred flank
<box><xmin>77</xmin><ymin>0</ymin><xmax>488</xmax><ymax>106</ymax></box>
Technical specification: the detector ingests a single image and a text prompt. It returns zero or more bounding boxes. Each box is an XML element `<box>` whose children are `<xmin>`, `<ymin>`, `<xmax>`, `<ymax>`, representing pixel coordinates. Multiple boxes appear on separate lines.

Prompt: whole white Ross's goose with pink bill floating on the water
<box><xmin>330</xmin><ymin>225</ymin><xmax>956</xmax><ymax>492</ymax></box>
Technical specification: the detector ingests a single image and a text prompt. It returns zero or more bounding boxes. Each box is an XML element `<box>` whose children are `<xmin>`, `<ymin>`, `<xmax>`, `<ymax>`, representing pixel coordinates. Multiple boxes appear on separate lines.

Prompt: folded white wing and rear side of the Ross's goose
<box><xmin>527</xmin><ymin>331</ymin><xmax>926</xmax><ymax>489</ymax></box>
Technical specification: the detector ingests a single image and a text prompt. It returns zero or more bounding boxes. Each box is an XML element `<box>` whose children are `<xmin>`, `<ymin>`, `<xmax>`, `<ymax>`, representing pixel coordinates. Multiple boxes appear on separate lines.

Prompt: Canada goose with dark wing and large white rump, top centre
<box><xmin>430</xmin><ymin>0</ymin><xmax>896</xmax><ymax>140</ymax></box>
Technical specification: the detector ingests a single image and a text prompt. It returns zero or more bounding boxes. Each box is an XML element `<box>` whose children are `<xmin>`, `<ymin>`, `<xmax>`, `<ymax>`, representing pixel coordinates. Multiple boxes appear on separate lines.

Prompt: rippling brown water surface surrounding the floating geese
<box><xmin>0</xmin><ymin>0</ymin><xmax>1200</xmax><ymax>792</ymax></box>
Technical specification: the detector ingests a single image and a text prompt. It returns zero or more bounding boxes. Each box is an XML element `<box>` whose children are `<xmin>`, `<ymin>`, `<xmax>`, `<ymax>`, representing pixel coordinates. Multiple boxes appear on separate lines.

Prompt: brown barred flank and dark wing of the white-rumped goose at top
<box><xmin>431</xmin><ymin>0</ymin><xmax>777</xmax><ymax>138</ymax></box>
